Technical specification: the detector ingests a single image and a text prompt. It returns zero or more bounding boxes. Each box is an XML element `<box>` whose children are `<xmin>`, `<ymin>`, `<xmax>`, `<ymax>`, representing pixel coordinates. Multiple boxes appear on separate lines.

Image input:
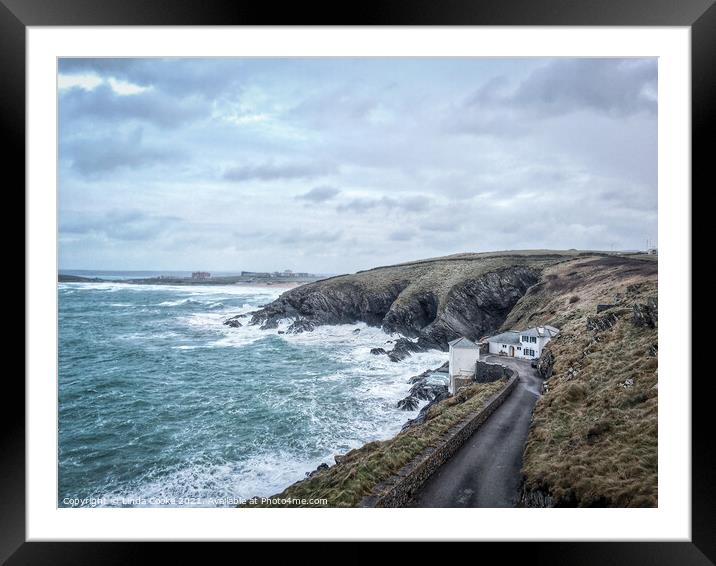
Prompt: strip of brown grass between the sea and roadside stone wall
<box><xmin>251</xmin><ymin>380</ymin><xmax>505</xmax><ymax>507</ymax></box>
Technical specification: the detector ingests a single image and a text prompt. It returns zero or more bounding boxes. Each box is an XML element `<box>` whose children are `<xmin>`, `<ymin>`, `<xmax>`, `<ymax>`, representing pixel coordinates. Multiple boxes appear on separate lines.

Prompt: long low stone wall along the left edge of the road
<box><xmin>359</xmin><ymin>368</ymin><xmax>519</xmax><ymax>507</ymax></box>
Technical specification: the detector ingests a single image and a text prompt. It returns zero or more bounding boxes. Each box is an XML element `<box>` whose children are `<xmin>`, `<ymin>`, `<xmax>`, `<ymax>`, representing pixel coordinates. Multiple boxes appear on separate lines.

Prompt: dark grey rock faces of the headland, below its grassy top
<box><xmin>243</xmin><ymin>263</ymin><xmax>540</xmax><ymax>352</ymax></box>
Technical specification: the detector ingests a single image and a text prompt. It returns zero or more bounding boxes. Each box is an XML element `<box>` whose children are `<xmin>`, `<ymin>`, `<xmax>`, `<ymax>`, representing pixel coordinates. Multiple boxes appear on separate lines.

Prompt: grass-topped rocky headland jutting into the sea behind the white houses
<box><xmin>227</xmin><ymin>252</ymin><xmax>576</xmax><ymax>361</ymax></box>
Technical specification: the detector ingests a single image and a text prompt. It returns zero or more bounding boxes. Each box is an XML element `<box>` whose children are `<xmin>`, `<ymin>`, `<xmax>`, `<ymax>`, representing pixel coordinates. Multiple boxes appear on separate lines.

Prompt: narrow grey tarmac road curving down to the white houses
<box><xmin>413</xmin><ymin>355</ymin><xmax>542</xmax><ymax>507</ymax></box>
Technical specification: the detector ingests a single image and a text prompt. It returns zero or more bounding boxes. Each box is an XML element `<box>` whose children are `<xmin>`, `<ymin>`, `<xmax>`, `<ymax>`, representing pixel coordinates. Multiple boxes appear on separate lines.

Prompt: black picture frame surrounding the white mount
<box><xmin>7</xmin><ymin>0</ymin><xmax>704</xmax><ymax>566</ymax></box>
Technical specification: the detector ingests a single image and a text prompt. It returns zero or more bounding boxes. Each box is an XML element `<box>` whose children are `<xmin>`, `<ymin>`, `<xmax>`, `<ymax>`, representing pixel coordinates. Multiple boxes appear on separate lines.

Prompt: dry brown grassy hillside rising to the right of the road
<box><xmin>513</xmin><ymin>255</ymin><xmax>658</xmax><ymax>507</ymax></box>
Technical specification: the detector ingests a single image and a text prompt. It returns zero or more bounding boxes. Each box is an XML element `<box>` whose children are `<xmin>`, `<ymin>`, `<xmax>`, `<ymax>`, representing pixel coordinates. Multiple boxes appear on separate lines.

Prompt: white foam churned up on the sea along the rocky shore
<box><xmin>60</xmin><ymin>284</ymin><xmax>447</xmax><ymax>506</ymax></box>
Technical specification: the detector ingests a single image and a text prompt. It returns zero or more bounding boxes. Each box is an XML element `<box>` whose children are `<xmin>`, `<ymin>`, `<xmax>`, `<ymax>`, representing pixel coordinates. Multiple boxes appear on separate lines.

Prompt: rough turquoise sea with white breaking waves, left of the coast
<box><xmin>58</xmin><ymin>277</ymin><xmax>447</xmax><ymax>507</ymax></box>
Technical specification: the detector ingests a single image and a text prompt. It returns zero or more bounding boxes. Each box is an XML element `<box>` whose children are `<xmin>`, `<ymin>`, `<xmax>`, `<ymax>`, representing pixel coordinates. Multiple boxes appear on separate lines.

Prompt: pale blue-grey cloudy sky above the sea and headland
<box><xmin>58</xmin><ymin>58</ymin><xmax>657</xmax><ymax>273</ymax></box>
